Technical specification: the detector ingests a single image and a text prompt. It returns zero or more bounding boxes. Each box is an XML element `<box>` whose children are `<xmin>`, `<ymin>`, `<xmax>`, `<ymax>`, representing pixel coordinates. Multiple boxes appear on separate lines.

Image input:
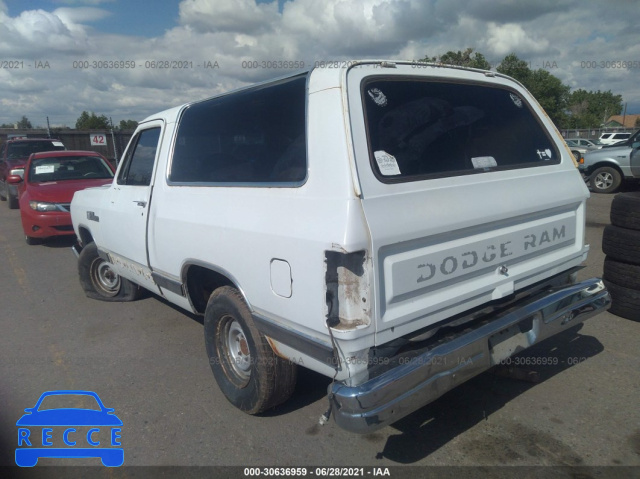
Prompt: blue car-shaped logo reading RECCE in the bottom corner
<box><xmin>16</xmin><ymin>390</ymin><xmax>124</xmax><ymax>467</ymax></box>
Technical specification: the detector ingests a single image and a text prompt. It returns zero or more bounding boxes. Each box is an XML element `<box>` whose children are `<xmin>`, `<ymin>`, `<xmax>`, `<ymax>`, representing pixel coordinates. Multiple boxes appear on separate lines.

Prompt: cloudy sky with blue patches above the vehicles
<box><xmin>0</xmin><ymin>0</ymin><xmax>640</xmax><ymax>126</ymax></box>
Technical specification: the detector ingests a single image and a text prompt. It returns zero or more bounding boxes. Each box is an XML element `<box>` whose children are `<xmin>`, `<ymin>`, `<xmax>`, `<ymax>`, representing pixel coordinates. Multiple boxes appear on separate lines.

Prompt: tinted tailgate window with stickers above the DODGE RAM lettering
<box><xmin>362</xmin><ymin>78</ymin><xmax>560</xmax><ymax>182</ymax></box>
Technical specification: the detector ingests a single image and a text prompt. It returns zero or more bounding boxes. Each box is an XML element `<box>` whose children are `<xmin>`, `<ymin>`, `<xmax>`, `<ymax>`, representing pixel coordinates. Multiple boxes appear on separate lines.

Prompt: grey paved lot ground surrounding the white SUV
<box><xmin>0</xmin><ymin>190</ymin><xmax>640</xmax><ymax>477</ymax></box>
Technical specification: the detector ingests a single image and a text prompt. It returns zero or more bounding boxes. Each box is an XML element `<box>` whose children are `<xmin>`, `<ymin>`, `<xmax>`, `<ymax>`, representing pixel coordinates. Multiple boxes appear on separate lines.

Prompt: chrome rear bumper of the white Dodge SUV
<box><xmin>329</xmin><ymin>278</ymin><xmax>611</xmax><ymax>434</ymax></box>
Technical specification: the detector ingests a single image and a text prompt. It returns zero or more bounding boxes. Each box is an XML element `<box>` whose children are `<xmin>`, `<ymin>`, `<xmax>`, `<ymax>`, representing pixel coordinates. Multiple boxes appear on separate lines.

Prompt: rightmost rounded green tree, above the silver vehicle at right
<box><xmin>569</xmin><ymin>89</ymin><xmax>622</xmax><ymax>128</ymax></box>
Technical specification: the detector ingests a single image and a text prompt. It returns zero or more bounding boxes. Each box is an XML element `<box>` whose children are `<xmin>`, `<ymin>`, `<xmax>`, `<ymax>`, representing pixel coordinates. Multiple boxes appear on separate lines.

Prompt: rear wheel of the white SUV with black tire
<box><xmin>204</xmin><ymin>286</ymin><xmax>297</xmax><ymax>414</ymax></box>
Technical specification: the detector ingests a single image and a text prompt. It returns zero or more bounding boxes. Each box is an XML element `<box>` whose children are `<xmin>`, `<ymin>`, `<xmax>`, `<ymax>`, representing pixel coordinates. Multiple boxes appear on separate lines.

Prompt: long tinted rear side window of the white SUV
<box><xmin>169</xmin><ymin>76</ymin><xmax>307</xmax><ymax>186</ymax></box>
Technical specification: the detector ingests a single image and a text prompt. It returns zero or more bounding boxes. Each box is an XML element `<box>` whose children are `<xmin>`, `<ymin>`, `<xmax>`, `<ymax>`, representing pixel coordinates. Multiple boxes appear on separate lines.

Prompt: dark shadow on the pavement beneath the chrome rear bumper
<box><xmin>365</xmin><ymin>325</ymin><xmax>604</xmax><ymax>464</ymax></box>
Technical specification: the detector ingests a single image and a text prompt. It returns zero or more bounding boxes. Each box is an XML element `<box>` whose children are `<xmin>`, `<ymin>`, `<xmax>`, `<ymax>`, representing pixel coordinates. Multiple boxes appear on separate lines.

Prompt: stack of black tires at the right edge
<box><xmin>602</xmin><ymin>192</ymin><xmax>640</xmax><ymax>321</ymax></box>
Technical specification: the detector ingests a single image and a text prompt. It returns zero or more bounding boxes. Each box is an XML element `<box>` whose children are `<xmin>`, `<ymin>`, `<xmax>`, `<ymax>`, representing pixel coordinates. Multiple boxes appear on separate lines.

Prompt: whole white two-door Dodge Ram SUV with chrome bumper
<box><xmin>71</xmin><ymin>61</ymin><xmax>610</xmax><ymax>433</ymax></box>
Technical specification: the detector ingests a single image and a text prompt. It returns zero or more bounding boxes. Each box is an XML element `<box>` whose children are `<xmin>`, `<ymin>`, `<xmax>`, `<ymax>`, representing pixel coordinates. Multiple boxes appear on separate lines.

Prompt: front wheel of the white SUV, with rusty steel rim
<box><xmin>78</xmin><ymin>243</ymin><xmax>141</xmax><ymax>301</ymax></box>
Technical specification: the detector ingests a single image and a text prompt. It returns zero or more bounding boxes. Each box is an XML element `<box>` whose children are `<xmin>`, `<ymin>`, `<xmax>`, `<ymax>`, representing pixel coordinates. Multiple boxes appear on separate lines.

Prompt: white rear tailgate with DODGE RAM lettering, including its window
<box><xmin>347</xmin><ymin>65</ymin><xmax>588</xmax><ymax>344</ymax></box>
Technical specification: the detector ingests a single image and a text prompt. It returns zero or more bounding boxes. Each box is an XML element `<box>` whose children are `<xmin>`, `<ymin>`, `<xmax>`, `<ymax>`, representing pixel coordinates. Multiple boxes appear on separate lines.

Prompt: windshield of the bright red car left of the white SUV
<box><xmin>28</xmin><ymin>156</ymin><xmax>113</xmax><ymax>183</ymax></box>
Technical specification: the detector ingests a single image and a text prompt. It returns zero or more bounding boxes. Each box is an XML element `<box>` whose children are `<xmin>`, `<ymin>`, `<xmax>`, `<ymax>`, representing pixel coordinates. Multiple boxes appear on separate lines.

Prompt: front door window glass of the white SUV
<box><xmin>118</xmin><ymin>128</ymin><xmax>160</xmax><ymax>186</ymax></box>
